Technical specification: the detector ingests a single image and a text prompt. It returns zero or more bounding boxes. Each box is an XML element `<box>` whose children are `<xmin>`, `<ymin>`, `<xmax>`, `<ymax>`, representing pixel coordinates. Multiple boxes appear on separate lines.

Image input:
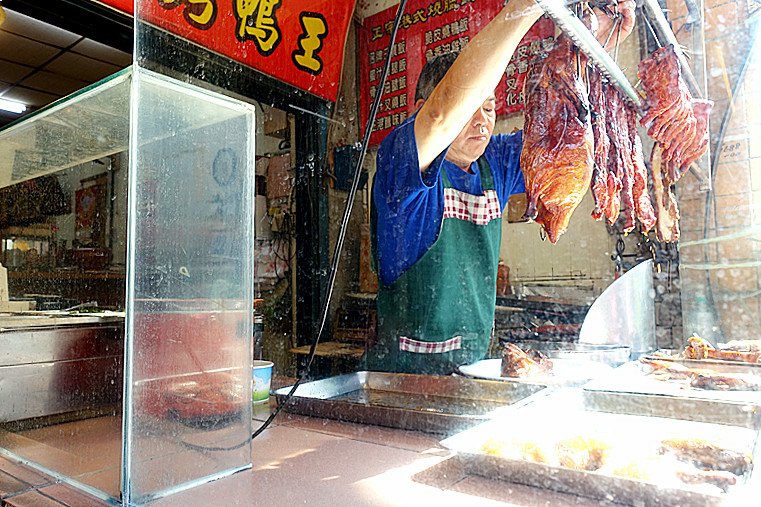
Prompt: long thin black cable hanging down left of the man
<box><xmin>251</xmin><ymin>0</ymin><xmax>407</xmax><ymax>439</ymax></box>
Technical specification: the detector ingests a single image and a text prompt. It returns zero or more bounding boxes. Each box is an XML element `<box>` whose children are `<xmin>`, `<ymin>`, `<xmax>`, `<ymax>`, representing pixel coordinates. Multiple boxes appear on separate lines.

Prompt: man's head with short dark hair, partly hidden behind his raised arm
<box><xmin>415</xmin><ymin>53</ymin><xmax>497</xmax><ymax>169</ymax></box>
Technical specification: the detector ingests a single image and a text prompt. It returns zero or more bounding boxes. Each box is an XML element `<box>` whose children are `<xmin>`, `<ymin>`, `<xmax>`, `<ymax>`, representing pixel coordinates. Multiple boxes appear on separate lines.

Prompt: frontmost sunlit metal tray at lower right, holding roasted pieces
<box><xmin>441</xmin><ymin>389</ymin><xmax>760</xmax><ymax>507</ymax></box>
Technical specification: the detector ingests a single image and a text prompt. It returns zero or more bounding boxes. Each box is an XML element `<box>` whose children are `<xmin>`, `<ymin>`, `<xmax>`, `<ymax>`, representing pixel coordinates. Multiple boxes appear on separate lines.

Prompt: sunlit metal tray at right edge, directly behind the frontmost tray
<box><xmin>583</xmin><ymin>362</ymin><xmax>761</xmax><ymax>429</ymax></box>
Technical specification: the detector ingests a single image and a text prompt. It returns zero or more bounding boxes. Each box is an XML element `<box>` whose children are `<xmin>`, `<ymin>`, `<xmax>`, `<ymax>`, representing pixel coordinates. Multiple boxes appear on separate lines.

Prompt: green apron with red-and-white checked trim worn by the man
<box><xmin>365</xmin><ymin>157</ymin><xmax>502</xmax><ymax>375</ymax></box>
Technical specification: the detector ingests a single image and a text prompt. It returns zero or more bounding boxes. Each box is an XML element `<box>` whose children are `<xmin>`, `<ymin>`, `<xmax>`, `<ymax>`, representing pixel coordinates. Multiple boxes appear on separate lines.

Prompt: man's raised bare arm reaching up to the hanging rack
<box><xmin>415</xmin><ymin>0</ymin><xmax>542</xmax><ymax>171</ymax></box>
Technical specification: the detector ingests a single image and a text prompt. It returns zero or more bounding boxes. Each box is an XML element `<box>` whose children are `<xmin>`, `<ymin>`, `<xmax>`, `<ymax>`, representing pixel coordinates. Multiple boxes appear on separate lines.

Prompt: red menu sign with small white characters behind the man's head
<box><xmin>359</xmin><ymin>0</ymin><xmax>555</xmax><ymax>145</ymax></box>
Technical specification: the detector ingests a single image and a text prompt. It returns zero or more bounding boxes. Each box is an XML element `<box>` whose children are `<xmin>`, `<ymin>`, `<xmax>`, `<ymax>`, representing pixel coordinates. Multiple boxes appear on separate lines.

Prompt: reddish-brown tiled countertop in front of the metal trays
<box><xmin>0</xmin><ymin>382</ymin><xmax>606</xmax><ymax>507</ymax></box>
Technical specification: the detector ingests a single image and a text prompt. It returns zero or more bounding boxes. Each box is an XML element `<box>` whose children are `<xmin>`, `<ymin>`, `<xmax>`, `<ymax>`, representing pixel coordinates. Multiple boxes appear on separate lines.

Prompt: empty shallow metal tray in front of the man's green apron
<box><xmin>275</xmin><ymin>371</ymin><xmax>546</xmax><ymax>434</ymax></box>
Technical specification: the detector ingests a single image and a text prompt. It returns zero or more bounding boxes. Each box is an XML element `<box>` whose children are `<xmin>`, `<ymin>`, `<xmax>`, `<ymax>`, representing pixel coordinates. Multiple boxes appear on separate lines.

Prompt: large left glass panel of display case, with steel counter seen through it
<box><xmin>0</xmin><ymin>69</ymin><xmax>131</xmax><ymax>504</ymax></box>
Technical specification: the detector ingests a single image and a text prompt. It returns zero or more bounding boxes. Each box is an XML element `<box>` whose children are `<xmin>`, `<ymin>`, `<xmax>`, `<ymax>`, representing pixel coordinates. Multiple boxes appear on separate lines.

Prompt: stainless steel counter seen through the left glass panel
<box><xmin>0</xmin><ymin>315</ymin><xmax>124</xmax><ymax>424</ymax></box>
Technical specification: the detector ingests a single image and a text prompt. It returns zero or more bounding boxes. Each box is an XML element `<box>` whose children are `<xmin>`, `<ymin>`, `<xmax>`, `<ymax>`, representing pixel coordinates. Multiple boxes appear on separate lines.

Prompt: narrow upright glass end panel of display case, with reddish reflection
<box><xmin>123</xmin><ymin>69</ymin><xmax>254</xmax><ymax>502</ymax></box>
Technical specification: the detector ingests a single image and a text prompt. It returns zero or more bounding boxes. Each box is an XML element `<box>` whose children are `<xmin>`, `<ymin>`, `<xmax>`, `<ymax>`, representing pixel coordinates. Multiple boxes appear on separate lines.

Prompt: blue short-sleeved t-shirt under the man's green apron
<box><xmin>373</xmin><ymin>115</ymin><xmax>526</xmax><ymax>285</ymax></box>
